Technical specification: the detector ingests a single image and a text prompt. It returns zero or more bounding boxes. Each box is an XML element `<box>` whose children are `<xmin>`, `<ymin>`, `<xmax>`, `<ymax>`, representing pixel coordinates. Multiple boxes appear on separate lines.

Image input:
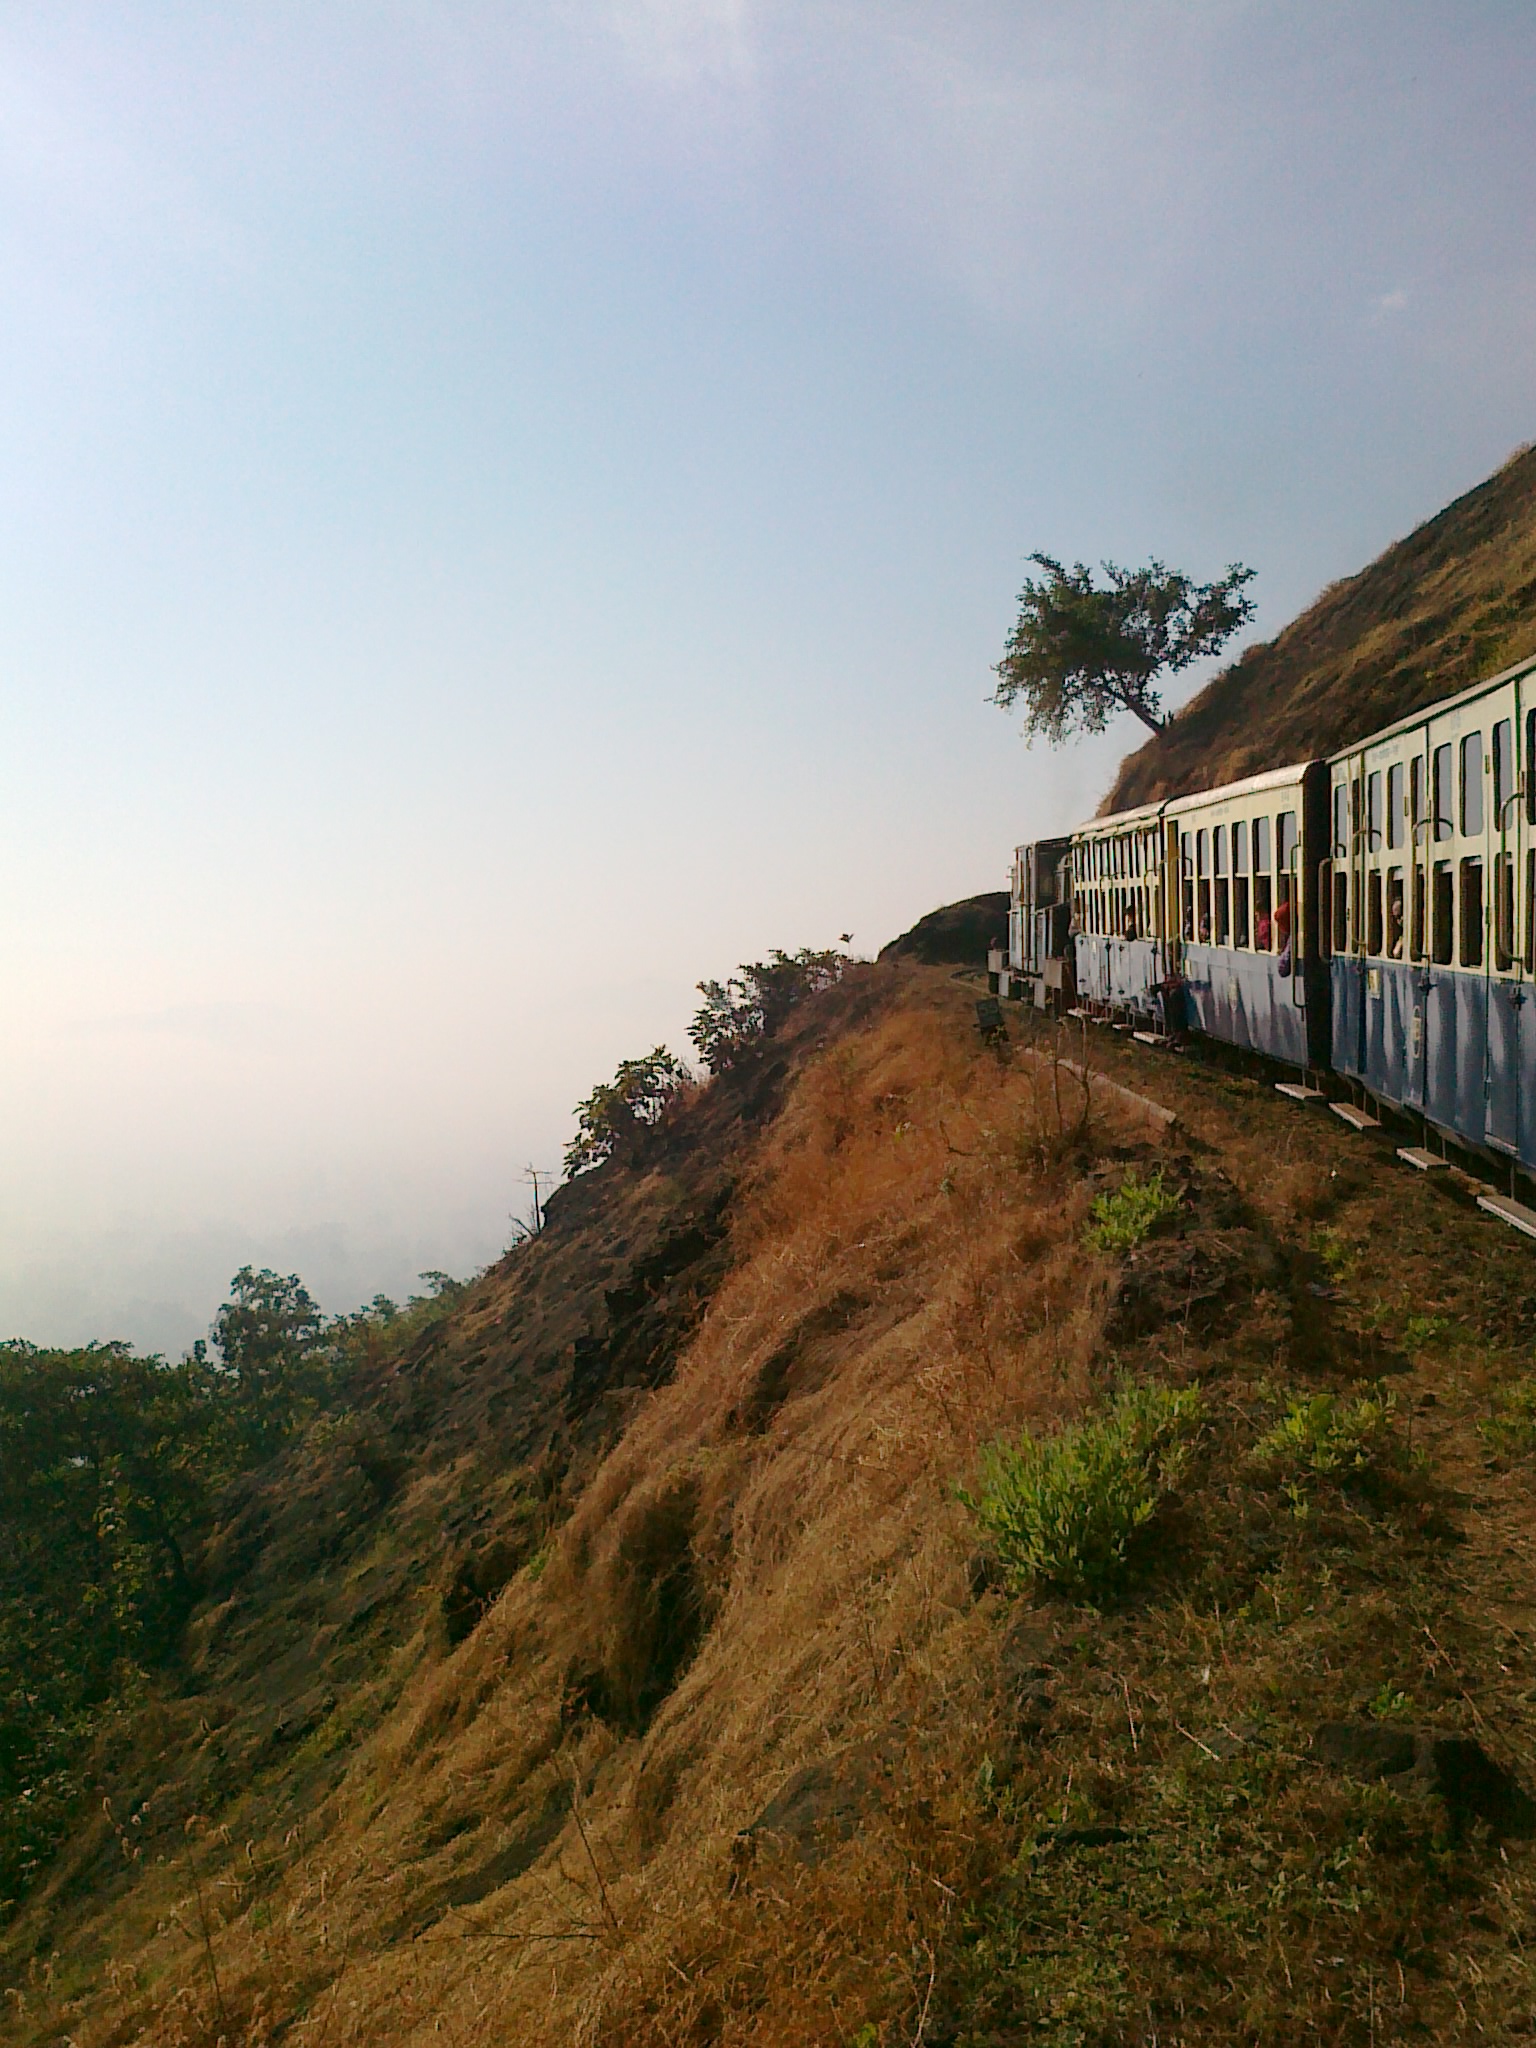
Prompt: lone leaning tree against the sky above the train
<box><xmin>991</xmin><ymin>555</ymin><xmax>1253</xmax><ymax>745</ymax></box>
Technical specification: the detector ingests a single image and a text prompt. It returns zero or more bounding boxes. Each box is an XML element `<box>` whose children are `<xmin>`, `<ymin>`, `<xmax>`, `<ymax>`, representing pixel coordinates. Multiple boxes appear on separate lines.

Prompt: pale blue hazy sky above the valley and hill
<box><xmin>0</xmin><ymin>0</ymin><xmax>1536</xmax><ymax>1354</ymax></box>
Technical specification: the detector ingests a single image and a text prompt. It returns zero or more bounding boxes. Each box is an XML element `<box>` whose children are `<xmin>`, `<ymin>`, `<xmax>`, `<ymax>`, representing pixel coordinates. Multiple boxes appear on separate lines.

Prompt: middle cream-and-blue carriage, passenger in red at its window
<box><xmin>1163</xmin><ymin>762</ymin><xmax>1329</xmax><ymax>1069</ymax></box>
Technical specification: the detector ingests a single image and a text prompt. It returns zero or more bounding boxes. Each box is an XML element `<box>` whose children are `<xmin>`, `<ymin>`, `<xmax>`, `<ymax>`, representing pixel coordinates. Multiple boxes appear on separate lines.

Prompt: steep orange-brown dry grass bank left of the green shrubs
<box><xmin>24</xmin><ymin>977</ymin><xmax>1147</xmax><ymax>2048</ymax></box>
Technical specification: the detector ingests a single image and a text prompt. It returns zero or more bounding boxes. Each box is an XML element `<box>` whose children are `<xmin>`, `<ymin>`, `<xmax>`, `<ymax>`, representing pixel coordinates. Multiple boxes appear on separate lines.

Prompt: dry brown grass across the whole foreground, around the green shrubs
<box><xmin>12</xmin><ymin>975</ymin><xmax>1536</xmax><ymax>2048</ymax></box>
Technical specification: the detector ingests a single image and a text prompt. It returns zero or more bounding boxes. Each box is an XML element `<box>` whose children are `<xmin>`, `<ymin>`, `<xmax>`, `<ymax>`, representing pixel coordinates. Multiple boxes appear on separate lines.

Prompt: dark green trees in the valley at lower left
<box><xmin>0</xmin><ymin>1266</ymin><xmax>461</xmax><ymax>1917</ymax></box>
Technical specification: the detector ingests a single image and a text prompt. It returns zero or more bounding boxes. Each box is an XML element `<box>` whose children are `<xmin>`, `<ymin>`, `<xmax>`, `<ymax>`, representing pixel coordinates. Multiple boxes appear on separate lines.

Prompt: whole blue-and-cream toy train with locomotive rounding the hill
<box><xmin>993</xmin><ymin>638</ymin><xmax>1536</xmax><ymax>1171</ymax></box>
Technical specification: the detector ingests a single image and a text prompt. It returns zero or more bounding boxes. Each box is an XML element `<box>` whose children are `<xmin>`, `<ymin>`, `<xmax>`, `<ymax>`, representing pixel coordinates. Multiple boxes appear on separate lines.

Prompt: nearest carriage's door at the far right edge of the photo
<box><xmin>1483</xmin><ymin>686</ymin><xmax>1530</xmax><ymax>1153</ymax></box>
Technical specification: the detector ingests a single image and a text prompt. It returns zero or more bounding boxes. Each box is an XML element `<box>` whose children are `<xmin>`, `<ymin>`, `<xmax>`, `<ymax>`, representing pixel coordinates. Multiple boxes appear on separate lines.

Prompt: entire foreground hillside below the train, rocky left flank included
<box><xmin>0</xmin><ymin>961</ymin><xmax>1536</xmax><ymax>2048</ymax></box>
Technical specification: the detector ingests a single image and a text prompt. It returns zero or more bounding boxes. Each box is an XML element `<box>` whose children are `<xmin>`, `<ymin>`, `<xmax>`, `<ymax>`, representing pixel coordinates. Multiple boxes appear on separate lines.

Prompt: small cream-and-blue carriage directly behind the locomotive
<box><xmin>1071</xmin><ymin>803</ymin><xmax>1174</xmax><ymax>1028</ymax></box>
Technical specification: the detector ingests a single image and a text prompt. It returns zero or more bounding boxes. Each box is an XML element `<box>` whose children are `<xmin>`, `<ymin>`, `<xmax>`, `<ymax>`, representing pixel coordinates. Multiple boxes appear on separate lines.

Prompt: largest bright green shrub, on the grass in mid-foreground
<box><xmin>961</xmin><ymin>1382</ymin><xmax>1200</xmax><ymax>1606</ymax></box>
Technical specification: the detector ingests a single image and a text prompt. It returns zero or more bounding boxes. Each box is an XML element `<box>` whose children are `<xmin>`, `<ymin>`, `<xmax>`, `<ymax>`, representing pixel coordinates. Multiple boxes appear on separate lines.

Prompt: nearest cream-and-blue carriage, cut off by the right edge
<box><xmin>1321</xmin><ymin>659</ymin><xmax>1536</xmax><ymax>1169</ymax></box>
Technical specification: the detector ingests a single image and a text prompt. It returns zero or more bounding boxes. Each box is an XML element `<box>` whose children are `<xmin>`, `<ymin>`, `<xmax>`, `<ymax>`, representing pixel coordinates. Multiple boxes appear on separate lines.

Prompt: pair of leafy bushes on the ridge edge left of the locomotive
<box><xmin>565</xmin><ymin>946</ymin><xmax>848</xmax><ymax>1174</ymax></box>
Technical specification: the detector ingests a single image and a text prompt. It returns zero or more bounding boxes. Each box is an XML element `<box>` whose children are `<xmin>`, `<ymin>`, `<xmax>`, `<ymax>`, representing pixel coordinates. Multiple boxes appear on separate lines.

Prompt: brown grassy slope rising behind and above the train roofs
<box><xmin>1102</xmin><ymin>449</ymin><xmax>1536</xmax><ymax>811</ymax></box>
